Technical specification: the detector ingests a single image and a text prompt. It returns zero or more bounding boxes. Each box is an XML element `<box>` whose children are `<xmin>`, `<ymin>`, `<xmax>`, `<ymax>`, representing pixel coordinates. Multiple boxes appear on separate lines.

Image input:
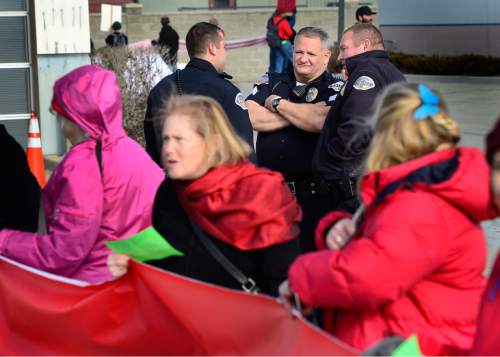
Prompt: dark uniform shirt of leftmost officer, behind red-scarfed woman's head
<box><xmin>144</xmin><ymin>58</ymin><xmax>253</xmax><ymax>166</ymax></box>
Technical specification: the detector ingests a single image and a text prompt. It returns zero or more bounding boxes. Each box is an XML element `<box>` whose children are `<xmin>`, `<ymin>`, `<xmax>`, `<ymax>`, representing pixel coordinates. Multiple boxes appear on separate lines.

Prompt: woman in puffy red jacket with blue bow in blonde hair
<box><xmin>280</xmin><ymin>83</ymin><xmax>496</xmax><ymax>355</ymax></box>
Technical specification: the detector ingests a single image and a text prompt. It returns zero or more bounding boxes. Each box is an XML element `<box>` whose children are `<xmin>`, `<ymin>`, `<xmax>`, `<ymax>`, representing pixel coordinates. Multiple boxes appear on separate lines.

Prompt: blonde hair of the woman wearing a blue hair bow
<box><xmin>365</xmin><ymin>83</ymin><xmax>460</xmax><ymax>172</ymax></box>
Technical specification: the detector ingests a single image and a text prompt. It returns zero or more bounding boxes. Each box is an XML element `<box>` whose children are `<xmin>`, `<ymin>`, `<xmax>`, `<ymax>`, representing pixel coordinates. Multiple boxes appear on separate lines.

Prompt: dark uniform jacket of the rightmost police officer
<box><xmin>312</xmin><ymin>50</ymin><xmax>406</xmax><ymax>180</ymax></box>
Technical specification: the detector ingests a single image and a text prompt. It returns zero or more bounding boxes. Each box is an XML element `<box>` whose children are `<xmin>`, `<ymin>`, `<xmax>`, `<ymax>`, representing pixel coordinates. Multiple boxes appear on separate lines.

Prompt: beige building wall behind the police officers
<box><xmin>90</xmin><ymin>2</ymin><xmax>364</xmax><ymax>82</ymax></box>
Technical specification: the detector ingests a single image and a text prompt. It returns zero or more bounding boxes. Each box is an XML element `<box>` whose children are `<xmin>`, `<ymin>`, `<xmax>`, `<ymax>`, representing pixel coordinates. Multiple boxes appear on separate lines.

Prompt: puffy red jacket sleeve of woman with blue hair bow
<box><xmin>288</xmin><ymin>192</ymin><xmax>449</xmax><ymax>309</ymax></box>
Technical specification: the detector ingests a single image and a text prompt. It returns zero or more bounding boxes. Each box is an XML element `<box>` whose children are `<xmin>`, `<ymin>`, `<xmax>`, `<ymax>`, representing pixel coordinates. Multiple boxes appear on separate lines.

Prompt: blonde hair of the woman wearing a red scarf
<box><xmin>161</xmin><ymin>95</ymin><xmax>251</xmax><ymax>167</ymax></box>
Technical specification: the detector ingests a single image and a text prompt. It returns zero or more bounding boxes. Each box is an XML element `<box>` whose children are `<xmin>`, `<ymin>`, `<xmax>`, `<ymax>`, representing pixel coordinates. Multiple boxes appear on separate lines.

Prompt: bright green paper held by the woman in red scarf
<box><xmin>105</xmin><ymin>227</ymin><xmax>184</xmax><ymax>262</ymax></box>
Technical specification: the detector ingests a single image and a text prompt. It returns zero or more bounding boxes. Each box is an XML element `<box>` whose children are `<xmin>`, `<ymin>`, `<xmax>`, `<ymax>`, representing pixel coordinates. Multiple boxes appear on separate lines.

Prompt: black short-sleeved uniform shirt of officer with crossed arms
<box><xmin>247</xmin><ymin>71</ymin><xmax>343</xmax><ymax>181</ymax></box>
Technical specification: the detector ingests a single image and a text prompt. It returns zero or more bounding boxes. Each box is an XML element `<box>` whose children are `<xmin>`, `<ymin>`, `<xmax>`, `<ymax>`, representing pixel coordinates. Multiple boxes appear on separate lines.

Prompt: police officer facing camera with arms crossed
<box><xmin>246</xmin><ymin>27</ymin><xmax>343</xmax><ymax>252</ymax></box>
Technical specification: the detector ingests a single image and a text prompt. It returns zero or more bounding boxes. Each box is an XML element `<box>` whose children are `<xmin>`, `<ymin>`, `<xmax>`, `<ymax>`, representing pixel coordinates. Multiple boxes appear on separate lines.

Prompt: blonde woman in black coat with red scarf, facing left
<box><xmin>108</xmin><ymin>95</ymin><xmax>301</xmax><ymax>296</ymax></box>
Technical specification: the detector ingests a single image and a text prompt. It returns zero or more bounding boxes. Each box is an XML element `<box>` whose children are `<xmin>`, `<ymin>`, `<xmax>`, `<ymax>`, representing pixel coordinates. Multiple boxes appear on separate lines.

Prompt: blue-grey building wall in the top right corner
<box><xmin>379</xmin><ymin>0</ymin><xmax>500</xmax><ymax>57</ymax></box>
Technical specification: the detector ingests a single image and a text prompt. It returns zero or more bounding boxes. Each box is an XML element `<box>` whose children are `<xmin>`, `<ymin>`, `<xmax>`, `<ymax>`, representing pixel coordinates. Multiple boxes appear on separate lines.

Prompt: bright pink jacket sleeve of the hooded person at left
<box><xmin>0</xmin><ymin>169</ymin><xmax>103</xmax><ymax>276</ymax></box>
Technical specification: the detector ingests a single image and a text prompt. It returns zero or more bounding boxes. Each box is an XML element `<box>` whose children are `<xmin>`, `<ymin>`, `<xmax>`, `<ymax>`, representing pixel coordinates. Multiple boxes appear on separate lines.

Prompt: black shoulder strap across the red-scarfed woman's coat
<box><xmin>189</xmin><ymin>219</ymin><xmax>259</xmax><ymax>294</ymax></box>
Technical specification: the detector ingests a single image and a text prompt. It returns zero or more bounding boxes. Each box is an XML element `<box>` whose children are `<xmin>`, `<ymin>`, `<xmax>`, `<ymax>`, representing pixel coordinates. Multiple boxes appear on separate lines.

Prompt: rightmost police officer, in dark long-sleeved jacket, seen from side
<box><xmin>313</xmin><ymin>23</ymin><xmax>406</xmax><ymax>213</ymax></box>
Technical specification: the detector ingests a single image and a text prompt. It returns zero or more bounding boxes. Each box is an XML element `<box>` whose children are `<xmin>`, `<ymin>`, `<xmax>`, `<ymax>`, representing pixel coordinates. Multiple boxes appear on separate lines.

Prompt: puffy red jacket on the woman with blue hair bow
<box><xmin>288</xmin><ymin>148</ymin><xmax>495</xmax><ymax>354</ymax></box>
